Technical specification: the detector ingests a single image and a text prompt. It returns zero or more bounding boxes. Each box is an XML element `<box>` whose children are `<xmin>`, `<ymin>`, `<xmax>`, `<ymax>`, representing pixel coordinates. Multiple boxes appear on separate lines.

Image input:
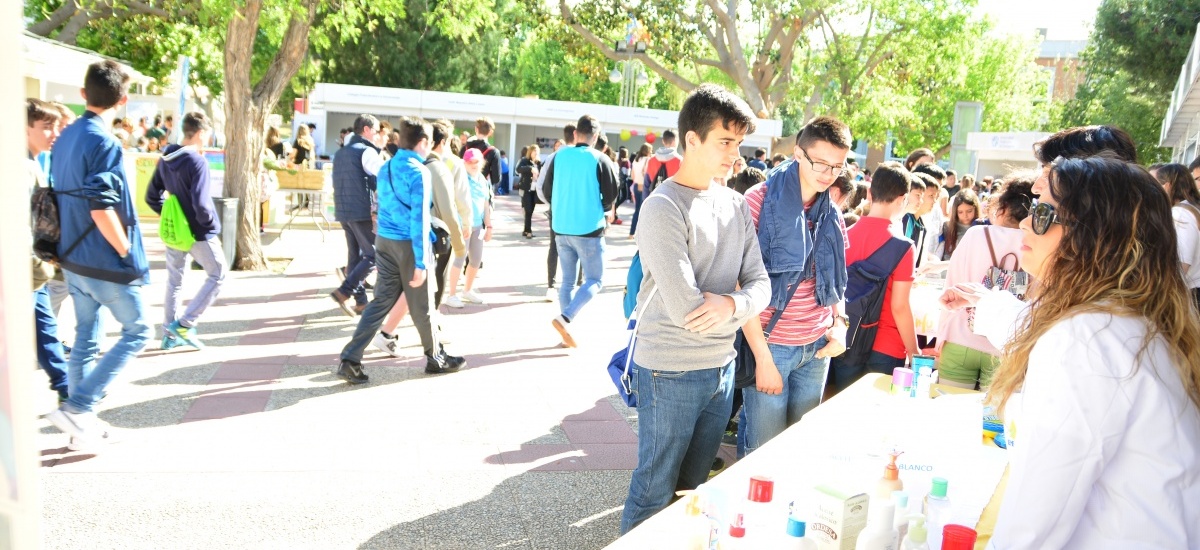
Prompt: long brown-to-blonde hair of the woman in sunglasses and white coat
<box><xmin>988</xmin><ymin>157</ymin><xmax>1200</xmax><ymax>407</ymax></box>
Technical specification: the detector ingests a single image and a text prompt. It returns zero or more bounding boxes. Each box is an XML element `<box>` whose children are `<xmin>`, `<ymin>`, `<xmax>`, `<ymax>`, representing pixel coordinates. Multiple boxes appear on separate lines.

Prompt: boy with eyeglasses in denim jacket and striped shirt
<box><xmin>738</xmin><ymin>116</ymin><xmax>853</xmax><ymax>456</ymax></box>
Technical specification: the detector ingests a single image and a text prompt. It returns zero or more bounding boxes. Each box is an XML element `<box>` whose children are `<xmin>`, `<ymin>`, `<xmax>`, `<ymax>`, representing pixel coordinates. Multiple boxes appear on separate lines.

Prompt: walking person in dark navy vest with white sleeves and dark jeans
<box><xmin>329</xmin><ymin>114</ymin><xmax>383</xmax><ymax>317</ymax></box>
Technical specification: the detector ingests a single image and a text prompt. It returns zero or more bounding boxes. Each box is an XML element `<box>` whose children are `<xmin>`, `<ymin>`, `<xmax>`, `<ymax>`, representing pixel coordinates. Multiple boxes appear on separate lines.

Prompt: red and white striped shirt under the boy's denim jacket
<box><xmin>746</xmin><ymin>184</ymin><xmax>850</xmax><ymax>346</ymax></box>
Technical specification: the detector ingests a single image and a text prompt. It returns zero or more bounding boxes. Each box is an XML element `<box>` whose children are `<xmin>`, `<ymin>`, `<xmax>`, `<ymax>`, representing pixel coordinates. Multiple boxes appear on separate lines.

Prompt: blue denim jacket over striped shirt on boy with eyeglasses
<box><xmin>758</xmin><ymin>161</ymin><xmax>846</xmax><ymax>309</ymax></box>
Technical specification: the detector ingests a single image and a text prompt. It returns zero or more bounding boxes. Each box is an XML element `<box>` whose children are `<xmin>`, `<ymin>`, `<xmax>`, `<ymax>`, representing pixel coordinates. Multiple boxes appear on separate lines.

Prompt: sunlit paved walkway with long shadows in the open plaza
<box><xmin>32</xmin><ymin>196</ymin><xmax>727</xmax><ymax>550</ymax></box>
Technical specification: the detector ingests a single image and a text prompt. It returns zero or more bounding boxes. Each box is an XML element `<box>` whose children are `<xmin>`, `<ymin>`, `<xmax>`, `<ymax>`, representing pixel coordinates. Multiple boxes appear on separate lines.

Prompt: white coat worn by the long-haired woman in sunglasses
<box><xmin>988</xmin><ymin>313</ymin><xmax>1200</xmax><ymax>550</ymax></box>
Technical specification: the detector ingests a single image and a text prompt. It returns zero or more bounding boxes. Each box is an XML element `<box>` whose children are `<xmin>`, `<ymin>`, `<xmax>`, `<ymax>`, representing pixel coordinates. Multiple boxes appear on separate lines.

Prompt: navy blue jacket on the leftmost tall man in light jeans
<box><xmin>50</xmin><ymin>112</ymin><xmax>150</xmax><ymax>285</ymax></box>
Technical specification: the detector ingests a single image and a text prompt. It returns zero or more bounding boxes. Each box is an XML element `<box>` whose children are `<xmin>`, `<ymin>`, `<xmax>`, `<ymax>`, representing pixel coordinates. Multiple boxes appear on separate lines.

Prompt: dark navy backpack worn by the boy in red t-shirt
<box><xmin>838</xmin><ymin>237</ymin><xmax>912</xmax><ymax>365</ymax></box>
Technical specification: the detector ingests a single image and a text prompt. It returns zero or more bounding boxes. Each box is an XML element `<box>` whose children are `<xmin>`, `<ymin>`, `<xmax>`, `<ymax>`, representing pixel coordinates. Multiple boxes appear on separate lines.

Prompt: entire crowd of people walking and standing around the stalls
<box><xmin>26</xmin><ymin>61</ymin><xmax>1200</xmax><ymax>548</ymax></box>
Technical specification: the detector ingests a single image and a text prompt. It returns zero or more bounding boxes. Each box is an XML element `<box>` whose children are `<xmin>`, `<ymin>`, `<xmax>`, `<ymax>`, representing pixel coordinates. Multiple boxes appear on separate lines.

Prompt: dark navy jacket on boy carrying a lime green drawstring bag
<box><xmin>146</xmin><ymin>144</ymin><xmax>221</xmax><ymax>240</ymax></box>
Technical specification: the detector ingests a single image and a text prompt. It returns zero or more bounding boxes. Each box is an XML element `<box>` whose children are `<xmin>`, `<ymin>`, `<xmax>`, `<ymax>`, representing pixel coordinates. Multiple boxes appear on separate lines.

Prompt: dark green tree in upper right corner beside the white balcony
<box><xmin>1058</xmin><ymin>0</ymin><xmax>1200</xmax><ymax>163</ymax></box>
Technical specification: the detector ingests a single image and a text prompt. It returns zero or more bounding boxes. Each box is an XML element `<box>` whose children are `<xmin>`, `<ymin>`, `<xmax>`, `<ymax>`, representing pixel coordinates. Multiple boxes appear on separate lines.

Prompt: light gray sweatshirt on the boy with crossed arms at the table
<box><xmin>634</xmin><ymin>179</ymin><xmax>770</xmax><ymax>371</ymax></box>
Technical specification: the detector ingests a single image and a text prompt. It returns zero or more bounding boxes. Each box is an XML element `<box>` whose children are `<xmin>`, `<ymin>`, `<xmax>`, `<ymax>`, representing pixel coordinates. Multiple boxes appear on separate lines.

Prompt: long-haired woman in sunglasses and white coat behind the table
<box><xmin>988</xmin><ymin>157</ymin><xmax>1200</xmax><ymax>550</ymax></box>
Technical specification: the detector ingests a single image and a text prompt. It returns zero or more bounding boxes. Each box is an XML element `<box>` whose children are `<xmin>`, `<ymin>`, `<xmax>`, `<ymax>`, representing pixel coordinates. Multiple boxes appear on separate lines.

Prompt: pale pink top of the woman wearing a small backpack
<box><xmin>937</xmin><ymin>226</ymin><xmax>1021</xmax><ymax>355</ymax></box>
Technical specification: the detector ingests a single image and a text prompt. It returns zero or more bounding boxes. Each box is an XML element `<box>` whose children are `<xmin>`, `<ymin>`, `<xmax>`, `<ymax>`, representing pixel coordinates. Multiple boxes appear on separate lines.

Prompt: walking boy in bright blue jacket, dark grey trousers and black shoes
<box><xmin>336</xmin><ymin>116</ymin><xmax>467</xmax><ymax>384</ymax></box>
